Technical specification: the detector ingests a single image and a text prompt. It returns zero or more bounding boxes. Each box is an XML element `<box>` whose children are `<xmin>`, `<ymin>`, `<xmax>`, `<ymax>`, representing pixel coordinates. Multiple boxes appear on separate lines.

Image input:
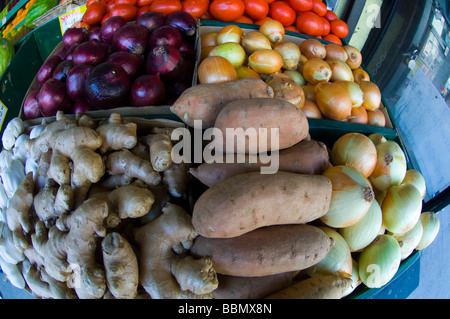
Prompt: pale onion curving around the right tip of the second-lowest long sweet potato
<box><xmin>306</xmin><ymin>227</ymin><xmax>353</xmax><ymax>278</ymax></box>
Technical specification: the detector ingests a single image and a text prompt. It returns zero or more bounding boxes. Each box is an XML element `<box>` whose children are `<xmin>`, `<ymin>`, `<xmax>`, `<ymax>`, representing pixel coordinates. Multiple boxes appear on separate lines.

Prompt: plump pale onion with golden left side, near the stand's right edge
<box><xmin>381</xmin><ymin>184</ymin><xmax>422</xmax><ymax>234</ymax></box>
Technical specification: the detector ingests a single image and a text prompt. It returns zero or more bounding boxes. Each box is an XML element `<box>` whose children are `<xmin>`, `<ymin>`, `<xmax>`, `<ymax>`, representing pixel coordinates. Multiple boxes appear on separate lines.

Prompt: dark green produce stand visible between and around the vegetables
<box><xmin>0</xmin><ymin>17</ymin><xmax>440</xmax><ymax>299</ymax></box>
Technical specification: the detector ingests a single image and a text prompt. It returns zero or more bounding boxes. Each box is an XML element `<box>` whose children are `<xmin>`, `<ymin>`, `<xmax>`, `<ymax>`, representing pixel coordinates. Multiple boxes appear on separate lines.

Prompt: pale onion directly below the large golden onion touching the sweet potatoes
<box><xmin>339</xmin><ymin>201</ymin><xmax>383</xmax><ymax>252</ymax></box>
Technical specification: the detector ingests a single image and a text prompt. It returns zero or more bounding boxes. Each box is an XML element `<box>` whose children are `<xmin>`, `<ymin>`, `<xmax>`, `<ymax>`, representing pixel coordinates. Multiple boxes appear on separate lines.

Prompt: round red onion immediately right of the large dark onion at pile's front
<box><xmin>130</xmin><ymin>74</ymin><xmax>166</xmax><ymax>106</ymax></box>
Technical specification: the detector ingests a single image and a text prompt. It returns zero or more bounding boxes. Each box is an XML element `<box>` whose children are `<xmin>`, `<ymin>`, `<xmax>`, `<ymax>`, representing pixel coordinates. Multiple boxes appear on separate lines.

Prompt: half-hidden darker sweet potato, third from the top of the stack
<box><xmin>189</xmin><ymin>140</ymin><xmax>331</xmax><ymax>187</ymax></box>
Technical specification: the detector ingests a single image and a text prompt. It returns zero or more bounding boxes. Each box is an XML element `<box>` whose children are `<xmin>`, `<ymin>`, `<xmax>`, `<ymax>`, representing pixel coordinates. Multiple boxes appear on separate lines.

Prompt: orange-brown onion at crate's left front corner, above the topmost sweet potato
<box><xmin>198</xmin><ymin>56</ymin><xmax>238</xmax><ymax>84</ymax></box>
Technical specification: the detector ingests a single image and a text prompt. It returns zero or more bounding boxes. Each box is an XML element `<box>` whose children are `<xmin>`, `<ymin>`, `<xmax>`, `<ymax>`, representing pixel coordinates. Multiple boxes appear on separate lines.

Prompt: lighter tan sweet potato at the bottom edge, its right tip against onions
<box><xmin>267</xmin><ymin>275</ymin><xmax>352</xmax><ymax>299</ymax></box>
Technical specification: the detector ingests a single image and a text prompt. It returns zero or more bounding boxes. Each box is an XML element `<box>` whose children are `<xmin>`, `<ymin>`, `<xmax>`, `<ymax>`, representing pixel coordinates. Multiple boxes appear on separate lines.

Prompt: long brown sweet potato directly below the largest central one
<box><xmin>190</xmin><ymin>224</ymin><xmax>333</xmax><ymax>277</ymax></box>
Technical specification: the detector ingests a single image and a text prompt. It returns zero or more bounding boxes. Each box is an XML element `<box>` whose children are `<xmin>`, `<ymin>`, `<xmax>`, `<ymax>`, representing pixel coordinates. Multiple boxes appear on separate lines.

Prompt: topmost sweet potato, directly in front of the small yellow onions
<box><xmin>170</xmin><ymin>79</ymin><xmax>273</xmax><ymax>129</ymax></box>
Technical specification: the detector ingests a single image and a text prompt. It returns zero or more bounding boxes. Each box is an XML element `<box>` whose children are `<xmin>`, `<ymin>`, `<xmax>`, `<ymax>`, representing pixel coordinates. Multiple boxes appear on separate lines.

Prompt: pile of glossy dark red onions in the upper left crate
<box><xmin>23</xmin><ymin>11</ymin><xmax>197</xmax><ymax>119</ymax></box>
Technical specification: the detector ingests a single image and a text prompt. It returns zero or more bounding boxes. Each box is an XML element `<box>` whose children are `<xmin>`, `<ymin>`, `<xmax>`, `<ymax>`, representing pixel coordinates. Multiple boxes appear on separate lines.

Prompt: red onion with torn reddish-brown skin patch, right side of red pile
<box><xmin>146</xmin><ymin>46</ymin><xmax>182</xmax><ymax>74</ymax></box>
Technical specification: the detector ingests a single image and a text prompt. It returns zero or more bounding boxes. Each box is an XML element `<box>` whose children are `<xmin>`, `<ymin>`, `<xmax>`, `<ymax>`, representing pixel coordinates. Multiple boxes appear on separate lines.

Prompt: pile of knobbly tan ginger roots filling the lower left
<box><xmin>0</xmin><ymin>112</ymin><xmax>218</xmax><ymax>299</ymax></box>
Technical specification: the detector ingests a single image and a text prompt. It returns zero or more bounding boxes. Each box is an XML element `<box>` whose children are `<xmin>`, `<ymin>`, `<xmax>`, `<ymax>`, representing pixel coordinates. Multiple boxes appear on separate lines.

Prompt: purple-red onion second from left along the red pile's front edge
<box><xmin>38</xmin><ymin>78</ymin><xmax>71</xmax><ymax>116</ymax></box>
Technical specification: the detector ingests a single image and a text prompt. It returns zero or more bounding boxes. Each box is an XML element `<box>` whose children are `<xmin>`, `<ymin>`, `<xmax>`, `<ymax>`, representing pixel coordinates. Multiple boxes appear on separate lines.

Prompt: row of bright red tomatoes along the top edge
<box><xmin>82</xmin><ymin>0</ymin><xmax>348</xmax><ymax>44</ymax></box>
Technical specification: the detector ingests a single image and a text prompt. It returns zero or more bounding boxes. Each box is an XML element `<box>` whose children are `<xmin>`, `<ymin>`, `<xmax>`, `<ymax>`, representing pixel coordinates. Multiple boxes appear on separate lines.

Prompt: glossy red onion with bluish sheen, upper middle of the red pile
<box><xmin>112</xmin><ymin>23</ymin><xmax>148</xmax><ymax>54</ymax></box>
